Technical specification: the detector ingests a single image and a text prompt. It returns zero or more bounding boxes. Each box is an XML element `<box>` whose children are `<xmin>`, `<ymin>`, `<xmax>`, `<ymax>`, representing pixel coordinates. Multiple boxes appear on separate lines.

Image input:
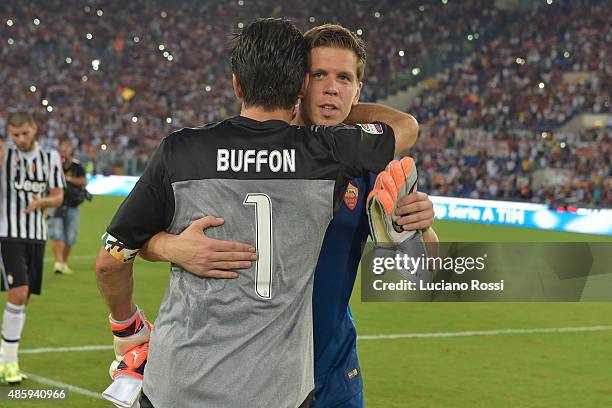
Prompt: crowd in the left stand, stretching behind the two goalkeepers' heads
<box><xmin>0</xmin><ymin>0</ymin><xmax>489</xmax><ymax>161</ymax></box>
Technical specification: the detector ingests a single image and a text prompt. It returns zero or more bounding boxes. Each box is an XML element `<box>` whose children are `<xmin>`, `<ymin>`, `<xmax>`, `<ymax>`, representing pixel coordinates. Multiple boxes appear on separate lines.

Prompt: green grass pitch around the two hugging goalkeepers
<box><xmin>0</xmin><ymin>197</ymin><xmax>612</xmax><ymax>408</ymax></box>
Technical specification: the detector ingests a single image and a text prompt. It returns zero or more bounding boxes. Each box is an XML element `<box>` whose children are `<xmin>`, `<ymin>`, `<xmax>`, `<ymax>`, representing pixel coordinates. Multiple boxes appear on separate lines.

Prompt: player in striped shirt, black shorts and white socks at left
<box><xmin>0</xmin><ymin>112</ymin><xmax>65</xmax><ymax>383</ymax></box>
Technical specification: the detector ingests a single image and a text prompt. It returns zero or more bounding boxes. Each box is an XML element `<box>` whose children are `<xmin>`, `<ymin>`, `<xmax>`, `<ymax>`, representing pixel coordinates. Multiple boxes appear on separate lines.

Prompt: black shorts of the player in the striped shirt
<box><xmin>0</xmin><ymin>240</ymin><xmax>45</xmax><ymax>295</ymax></box>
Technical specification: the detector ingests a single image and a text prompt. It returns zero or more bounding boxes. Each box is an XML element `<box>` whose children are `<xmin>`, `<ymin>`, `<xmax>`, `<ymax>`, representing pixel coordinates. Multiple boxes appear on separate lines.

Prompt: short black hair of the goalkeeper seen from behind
<box><xmin>231</xmin><ymin>18</ymin><xmax>308</xmax><ymax>111</ymax></box>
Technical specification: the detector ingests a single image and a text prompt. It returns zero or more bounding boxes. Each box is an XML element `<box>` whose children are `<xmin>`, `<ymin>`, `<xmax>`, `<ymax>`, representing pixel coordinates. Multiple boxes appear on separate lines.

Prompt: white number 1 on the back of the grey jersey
<box><xmin>243</xmin><ymin>193</ymin><xmax>272</xmax><ymax>299</ymax></box>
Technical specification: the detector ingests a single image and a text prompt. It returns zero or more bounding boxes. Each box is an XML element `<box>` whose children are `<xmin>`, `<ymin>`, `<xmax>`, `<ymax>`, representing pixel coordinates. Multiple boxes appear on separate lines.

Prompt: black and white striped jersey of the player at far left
<box><xmin>0</xmin><ymin>143</ymin><xmax>65</xmax><ymax>241</ymax></box>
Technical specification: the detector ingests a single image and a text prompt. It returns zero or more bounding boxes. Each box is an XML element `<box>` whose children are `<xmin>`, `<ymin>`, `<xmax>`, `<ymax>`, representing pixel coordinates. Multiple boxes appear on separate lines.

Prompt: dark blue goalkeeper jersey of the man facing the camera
<box><xmin>312</xmin><ymin>174</ymin><xmax>376</xmax><ymax>408</ymax></box>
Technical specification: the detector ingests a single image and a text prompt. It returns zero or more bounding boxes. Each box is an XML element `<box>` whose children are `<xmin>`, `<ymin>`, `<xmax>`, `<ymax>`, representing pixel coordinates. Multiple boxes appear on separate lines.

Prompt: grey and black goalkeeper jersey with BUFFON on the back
<box><xmin>107</xmin><ymin>117</ymin><xmax>395</xmax><ymax>408</ymax></box>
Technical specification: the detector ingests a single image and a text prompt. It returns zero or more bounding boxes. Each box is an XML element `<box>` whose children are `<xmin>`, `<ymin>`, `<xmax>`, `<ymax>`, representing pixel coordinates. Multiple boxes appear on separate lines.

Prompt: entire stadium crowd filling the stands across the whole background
<box><xmin>0</xmin><ymin>0</ymin><xmax>612</xmax><ymax>206</ymax></box>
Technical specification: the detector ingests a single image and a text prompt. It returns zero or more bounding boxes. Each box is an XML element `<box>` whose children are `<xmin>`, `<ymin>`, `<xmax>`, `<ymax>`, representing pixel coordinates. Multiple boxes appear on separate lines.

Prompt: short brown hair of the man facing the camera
<box><xmin>304</xmin><ymin>24</ymin><xmax>367</xmax><ymax>81</ymax></box>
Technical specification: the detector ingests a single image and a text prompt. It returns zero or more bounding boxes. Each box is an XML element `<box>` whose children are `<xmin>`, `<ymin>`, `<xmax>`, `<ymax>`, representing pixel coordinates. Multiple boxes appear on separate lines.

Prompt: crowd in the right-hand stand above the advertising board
<box><xmin>409</xmin><ymin>1</ymin><xmax>612</xmax><ymax>207</ymax></box>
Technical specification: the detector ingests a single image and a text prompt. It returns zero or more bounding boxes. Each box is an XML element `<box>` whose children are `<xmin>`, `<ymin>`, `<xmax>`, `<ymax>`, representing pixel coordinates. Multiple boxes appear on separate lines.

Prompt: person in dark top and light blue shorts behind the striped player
<box><xmin>47</xmin><ymin>140</ymin><xmax>91</xmax><ymax>275</ymax></box>
